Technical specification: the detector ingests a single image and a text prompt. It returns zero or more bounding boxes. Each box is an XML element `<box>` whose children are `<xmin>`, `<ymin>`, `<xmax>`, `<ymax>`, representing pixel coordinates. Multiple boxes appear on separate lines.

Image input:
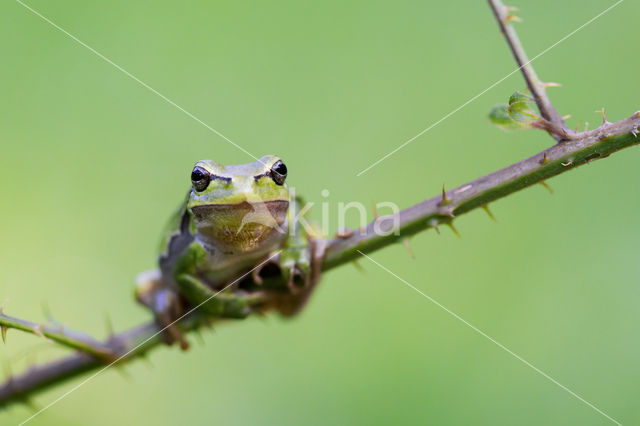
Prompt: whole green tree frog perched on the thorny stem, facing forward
<box><xmin>136</xmin><ymin>155</ymin><xmax>324</xmax><ymax>349</ymax></box>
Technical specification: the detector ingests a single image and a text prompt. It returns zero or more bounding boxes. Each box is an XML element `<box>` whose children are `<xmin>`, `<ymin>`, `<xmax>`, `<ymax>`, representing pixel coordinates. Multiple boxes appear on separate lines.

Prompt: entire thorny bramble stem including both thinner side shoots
<box><xmin>0</xmin><ymin>0</ymin><xmax>640</xmax><ymax>407</ymax></box>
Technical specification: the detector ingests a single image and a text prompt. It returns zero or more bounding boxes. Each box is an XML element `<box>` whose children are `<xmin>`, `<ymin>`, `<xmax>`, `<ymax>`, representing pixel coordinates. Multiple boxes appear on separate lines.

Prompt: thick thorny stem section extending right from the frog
<box><xmin>323</xmin><ymin>111</ymin><xmax>640</xmax><ymax>269</ymax></box>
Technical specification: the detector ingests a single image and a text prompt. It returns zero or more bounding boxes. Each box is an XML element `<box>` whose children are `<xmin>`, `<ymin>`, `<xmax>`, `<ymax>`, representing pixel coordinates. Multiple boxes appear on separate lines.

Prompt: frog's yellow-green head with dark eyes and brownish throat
<box><xmin>187</xmin><ymin>155</ymin><xmax>289</xmax><ymax>253</ymax></box>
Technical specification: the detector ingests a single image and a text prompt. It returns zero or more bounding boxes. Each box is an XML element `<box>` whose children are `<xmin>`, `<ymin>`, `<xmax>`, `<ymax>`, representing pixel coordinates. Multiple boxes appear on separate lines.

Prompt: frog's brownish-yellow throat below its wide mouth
<box><xmin>191</xmin><ymin>200</ymin><xmax>289</xmax><ymax>255</ymax></box>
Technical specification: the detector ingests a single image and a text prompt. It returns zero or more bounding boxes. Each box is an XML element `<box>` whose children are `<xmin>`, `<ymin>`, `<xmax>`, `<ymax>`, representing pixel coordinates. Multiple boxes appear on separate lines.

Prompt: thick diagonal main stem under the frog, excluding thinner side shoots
<box><xmin>0</xmin><ymin>112</ymin><xmax>640</xmax><ymax>406</ymax></box>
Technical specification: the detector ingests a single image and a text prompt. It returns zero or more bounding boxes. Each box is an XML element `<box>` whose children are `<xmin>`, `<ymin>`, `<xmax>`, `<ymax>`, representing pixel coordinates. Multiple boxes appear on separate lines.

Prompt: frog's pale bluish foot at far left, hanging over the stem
<box><xmin>136</xmin><ymin>270</ymin><xmax>189</xmax><ymax>350</ymax></box>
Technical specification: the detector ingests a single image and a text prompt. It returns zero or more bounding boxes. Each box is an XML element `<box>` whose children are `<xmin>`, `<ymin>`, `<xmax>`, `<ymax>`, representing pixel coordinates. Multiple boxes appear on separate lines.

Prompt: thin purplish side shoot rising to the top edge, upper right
<box><xmin>489</xmin><ymin>0</ymin><xmax>567</xmax><ymax>142</ymax></box>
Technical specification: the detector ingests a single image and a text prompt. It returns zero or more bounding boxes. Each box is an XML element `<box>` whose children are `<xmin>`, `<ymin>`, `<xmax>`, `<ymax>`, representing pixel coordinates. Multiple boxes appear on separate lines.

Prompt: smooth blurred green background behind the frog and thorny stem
<box><xmin>0</xmin><ymin>0</ymin><xmax>640</xmax><ymax>426</ymax></box>
